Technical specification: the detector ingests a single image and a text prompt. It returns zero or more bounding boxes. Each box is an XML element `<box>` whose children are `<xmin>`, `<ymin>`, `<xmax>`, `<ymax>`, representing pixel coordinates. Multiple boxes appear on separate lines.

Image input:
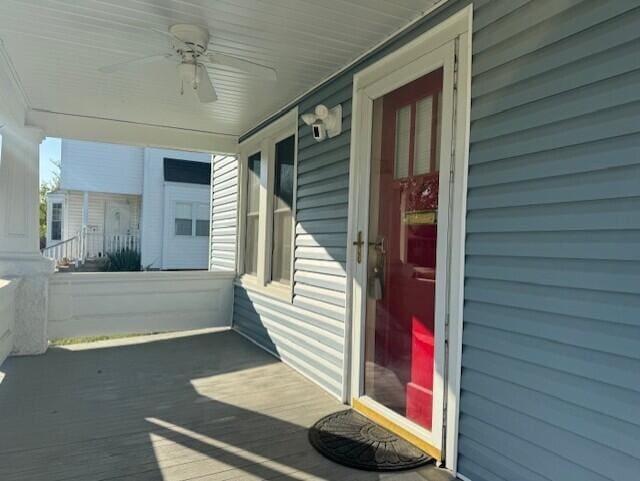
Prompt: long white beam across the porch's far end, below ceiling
<box><xmin>26</xmin><ymin>109</ymin><xmax>238</xmax><ymax>154</ymax></box>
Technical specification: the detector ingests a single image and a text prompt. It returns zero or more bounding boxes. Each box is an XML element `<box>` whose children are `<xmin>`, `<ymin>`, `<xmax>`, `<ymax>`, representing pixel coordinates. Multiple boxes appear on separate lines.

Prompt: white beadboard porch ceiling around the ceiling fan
<box><xmin>0</xmin><ymin>0</ymin><xmax>437</xmax><ymax>139</ymax></box>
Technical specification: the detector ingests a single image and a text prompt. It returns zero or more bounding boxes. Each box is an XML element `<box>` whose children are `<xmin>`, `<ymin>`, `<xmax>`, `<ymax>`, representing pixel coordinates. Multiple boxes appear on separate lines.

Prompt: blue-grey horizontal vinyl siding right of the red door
<box><xmin>459</xmin><ymin>1</ymin><xmax>640</xmax><ymax>481</ymax></box>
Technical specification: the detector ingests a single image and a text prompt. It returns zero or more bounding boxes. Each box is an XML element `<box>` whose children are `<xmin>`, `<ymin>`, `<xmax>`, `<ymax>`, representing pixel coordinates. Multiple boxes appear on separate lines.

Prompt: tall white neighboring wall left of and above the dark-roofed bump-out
<box><xmin>140</xmin><ymin>148</ymin><xmax>211</xmax><ymax>269</ymax></box>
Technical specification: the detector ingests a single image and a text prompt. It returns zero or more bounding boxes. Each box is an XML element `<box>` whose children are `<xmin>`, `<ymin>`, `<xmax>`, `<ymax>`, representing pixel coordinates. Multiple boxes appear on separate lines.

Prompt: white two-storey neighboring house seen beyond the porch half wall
<box><xmin>45</xmin><ymin>140</ymin><xmax>211</xmax><ymax>269</ymax></box>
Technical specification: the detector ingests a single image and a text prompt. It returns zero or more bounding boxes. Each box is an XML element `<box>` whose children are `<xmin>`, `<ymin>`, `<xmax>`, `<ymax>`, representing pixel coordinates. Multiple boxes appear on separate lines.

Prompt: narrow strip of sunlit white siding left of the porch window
<box><xmin>209</xmin><ymin>155</ymin><xmax>238</xmax><ymax>271</ymax></box>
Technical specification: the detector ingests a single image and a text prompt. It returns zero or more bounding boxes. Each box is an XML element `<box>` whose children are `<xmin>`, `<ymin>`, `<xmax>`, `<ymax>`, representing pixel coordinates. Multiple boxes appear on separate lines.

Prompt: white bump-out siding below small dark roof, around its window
<box><xmin>162</xmin><ymin>182</ymin><xmax>210</xmax><ymax>269</ymax></box>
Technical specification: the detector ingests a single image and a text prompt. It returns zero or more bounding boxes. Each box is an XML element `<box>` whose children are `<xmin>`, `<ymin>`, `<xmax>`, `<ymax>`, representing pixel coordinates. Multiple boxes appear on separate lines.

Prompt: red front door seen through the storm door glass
<box><xmin>365</xmin><ymin>69</ymin><xmax>442</xmax><ymax>430</ymax></box>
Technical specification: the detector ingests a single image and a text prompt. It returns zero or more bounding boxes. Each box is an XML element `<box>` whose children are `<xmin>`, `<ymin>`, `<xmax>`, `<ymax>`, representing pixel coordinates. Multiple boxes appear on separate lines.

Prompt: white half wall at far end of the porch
<box><xmin>48</xmin><ymin>271</ymin><xmax>234</xmax><ymax>339</ymax></box>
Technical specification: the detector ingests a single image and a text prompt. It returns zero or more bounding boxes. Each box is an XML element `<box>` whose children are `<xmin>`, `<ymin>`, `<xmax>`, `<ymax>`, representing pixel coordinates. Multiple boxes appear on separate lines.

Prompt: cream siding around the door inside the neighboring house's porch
<box><xmin>63</xmin><ymin>191</ymin><xmax>141</xmax><ymax>239</ymax></box>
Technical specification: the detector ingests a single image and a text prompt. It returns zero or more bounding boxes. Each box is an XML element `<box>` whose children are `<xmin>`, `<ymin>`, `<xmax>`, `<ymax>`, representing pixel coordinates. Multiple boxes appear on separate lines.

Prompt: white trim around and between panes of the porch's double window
<box><xmin>236</xmin><ymin>107</ymin><xmax>298</xmax><ymax>302</ymax></box>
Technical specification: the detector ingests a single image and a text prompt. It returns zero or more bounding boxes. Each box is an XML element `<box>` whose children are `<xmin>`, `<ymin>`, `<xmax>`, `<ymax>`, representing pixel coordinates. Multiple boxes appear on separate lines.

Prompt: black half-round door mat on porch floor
<box><xmin>309</xmin><ymin>409</ymin><xmax>434</xmax><ymax>471</ymax></box>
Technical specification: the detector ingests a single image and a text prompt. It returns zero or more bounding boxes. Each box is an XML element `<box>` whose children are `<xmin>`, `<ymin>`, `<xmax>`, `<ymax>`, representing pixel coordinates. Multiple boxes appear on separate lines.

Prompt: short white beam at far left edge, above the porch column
<box><xmin>0</xmin><ymin>39</ymin><xmax>30</xmax><ymax>127</ymax></box>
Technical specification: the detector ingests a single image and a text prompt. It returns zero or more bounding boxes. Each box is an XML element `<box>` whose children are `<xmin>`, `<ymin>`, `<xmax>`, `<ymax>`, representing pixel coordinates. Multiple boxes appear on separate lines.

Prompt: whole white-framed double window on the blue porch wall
<box><xmin>240</xmin><ymin>109</ymin><xmax>298</xmax><ymax>300</ymax></box>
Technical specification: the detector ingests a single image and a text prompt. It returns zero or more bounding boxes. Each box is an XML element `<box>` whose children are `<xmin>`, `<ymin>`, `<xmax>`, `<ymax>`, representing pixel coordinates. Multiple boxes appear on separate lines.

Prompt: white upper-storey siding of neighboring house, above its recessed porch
<box><xmin>60</xmin><ymin>139</ymin><xmax>144</xmax><ymax>195</ymax></box>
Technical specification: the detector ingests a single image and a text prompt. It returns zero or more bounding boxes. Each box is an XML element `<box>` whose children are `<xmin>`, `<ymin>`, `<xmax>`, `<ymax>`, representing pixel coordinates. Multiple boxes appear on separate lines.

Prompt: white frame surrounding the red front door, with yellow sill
<box><xmin>344</xmin><ymin>5</ymin><xmax>473</xmax><ymax>473</ymax></box>
